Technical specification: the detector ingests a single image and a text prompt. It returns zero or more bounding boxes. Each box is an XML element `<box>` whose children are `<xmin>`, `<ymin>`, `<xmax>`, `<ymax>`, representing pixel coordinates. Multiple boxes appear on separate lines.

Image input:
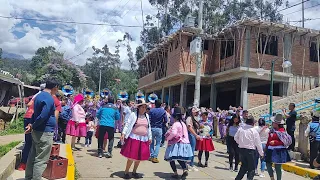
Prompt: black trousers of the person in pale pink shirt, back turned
<box><xmin>236</xmin><ymin>148</ymin><xmax>256</xmax><ymax>180</ymax></box>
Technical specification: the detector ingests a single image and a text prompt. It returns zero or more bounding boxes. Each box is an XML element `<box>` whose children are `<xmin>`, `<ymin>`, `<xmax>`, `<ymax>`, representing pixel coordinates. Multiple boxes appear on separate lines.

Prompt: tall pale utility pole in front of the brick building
<box><xmin>193</xmin><ymin>0</ymin><xmax>203</xmax><ymax>107</ymax></box>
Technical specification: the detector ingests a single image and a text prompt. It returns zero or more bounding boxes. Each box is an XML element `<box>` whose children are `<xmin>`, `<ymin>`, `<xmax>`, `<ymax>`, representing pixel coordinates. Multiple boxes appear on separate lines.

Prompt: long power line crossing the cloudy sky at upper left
<box><xmin>0</xmin><ymin>15</ymin><xmax>142</xmax><ymax>28</ymax></box>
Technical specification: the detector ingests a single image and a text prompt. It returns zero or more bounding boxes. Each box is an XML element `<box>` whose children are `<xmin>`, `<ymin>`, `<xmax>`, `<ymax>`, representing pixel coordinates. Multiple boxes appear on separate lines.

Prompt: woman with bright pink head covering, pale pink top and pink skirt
<box><xmin>66</xmin><ymin>94</ymin><xmax>87</xmax><ymax>149</ymax></box>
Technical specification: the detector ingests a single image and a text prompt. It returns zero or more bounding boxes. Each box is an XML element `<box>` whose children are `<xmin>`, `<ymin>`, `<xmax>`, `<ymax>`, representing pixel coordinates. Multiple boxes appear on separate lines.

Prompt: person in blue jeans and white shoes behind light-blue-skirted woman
<box><xmin>186</xmin><ymin>107</ymin><xmax>200</xmax><ymax>171</ymax></box>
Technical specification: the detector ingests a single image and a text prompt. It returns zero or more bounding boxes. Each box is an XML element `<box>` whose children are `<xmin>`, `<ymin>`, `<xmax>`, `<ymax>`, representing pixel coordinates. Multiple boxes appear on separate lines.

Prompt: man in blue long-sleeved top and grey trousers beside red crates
<box><xmin>25</xmin><ymin>80</ymin><xmax>58</xmax><ymax>180</ymax></box>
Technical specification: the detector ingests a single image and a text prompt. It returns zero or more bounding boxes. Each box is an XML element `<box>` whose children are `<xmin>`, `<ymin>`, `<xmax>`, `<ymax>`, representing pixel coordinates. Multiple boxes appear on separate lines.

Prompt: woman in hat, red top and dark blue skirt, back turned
<box><xmin>265</xmin><ymin>114</ymin><xmax>292</xmax><ymax>180</ymax></box>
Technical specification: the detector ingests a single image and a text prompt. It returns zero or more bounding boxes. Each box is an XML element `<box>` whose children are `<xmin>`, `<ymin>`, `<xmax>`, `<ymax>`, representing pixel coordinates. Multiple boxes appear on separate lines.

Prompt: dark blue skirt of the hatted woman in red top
<box><xmin>265</xmin><ymin>148</ymin><xmax>291</xmax><ymax>164</ymax></box>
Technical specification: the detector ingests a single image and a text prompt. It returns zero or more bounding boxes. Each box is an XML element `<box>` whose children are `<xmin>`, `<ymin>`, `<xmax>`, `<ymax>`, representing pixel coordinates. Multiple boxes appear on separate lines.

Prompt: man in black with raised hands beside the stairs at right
<box><xmin>282</xmin><ymin>103</ymin><xmax>297</xmax><ymax>151</ymax></box>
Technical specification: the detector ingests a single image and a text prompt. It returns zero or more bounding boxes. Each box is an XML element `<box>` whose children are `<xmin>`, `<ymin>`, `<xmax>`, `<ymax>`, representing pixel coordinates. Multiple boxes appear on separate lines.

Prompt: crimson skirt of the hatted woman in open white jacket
<box><xmin>120</xmin><ymin>137</ymin><xmax>150</xmax><ymax>161</ymax></box>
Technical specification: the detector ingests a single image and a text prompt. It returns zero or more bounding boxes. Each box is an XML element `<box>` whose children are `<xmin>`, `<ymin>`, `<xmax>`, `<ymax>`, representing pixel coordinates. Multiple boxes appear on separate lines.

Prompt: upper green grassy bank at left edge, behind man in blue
<box><xmin>0</xmin><ymin>113</ymin><xmax>24</xmax><ymax>136</ymax></box>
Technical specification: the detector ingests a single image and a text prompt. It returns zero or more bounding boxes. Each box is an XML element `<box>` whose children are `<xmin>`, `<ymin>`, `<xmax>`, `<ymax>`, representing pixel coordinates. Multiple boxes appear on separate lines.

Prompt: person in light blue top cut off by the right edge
<box><xmin>305</xmin><ymin>111</ymin><xmax>320</xmax><ymax>169</ymax></box>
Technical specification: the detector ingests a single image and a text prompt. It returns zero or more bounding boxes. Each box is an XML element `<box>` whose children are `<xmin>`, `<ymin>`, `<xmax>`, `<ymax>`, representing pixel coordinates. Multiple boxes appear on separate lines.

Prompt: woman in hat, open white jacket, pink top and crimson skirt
<box><xmin>120</xmin><ymin>99</ymin><xmax>152</xmax><ymax>179</ymax></box>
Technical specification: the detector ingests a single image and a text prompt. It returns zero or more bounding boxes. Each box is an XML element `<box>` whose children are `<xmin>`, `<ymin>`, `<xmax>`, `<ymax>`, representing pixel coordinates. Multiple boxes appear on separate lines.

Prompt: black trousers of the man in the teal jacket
<box><xmin>98</xmin><ymin>126</ymin><xmax>114</xmax><ymax>154</ymax></box>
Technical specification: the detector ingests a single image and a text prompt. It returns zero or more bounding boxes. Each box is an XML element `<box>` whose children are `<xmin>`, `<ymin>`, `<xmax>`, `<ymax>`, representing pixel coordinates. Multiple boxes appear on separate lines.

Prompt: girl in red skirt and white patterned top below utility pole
<box><xmin>196</xmin><ymin>112</ymin><xmax>214</xmax><ymax>167</ymax></box>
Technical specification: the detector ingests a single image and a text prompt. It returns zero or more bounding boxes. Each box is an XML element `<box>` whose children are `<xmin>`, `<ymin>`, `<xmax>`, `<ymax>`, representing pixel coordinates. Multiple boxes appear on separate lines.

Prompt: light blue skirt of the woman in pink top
<box><xmin>164</xmin><ymin>143</ymin><xmax>193</xmax><ymax>162</ymax></box>
